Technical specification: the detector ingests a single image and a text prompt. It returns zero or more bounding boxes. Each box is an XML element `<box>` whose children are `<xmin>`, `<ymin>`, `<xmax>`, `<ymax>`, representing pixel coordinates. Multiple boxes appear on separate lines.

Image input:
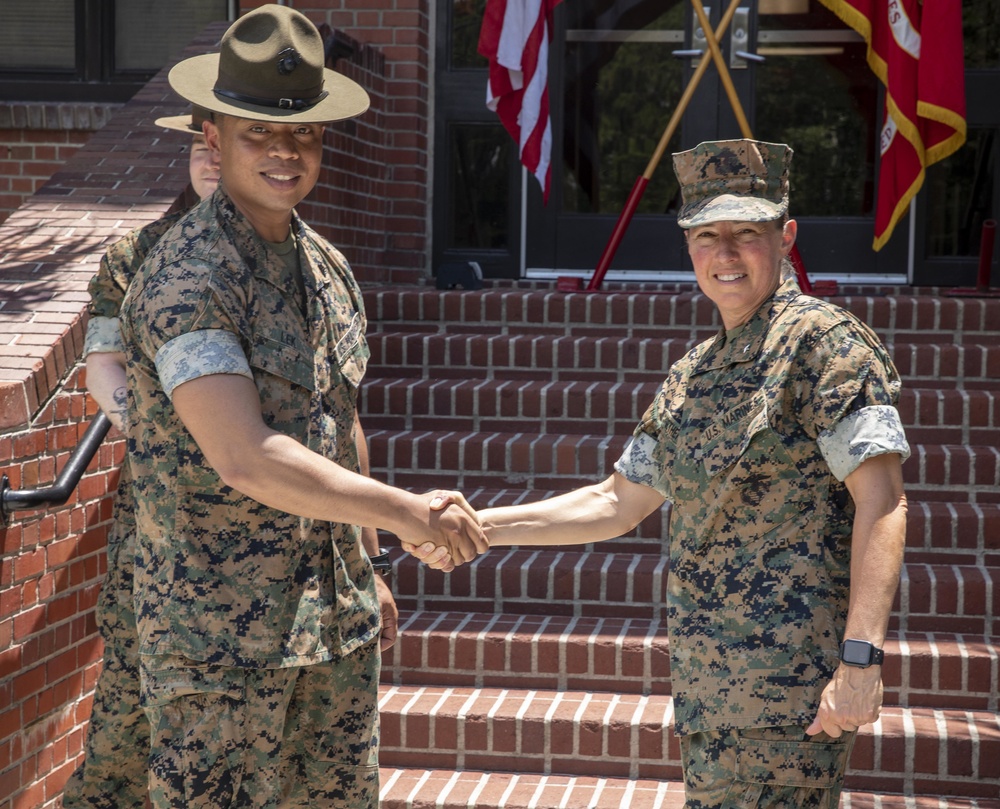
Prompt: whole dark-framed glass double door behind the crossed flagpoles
<box><xmin>526</xmin><ymin>0</ymin><xmax>907</xmax><ymax>280</ymax></box>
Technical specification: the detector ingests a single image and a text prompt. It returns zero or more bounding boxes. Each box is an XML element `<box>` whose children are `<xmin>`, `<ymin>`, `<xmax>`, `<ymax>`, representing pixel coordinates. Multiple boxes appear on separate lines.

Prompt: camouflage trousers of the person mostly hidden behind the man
<box><xmin>63</xmin><ymin>520</ymin><xmax>149</xmax><ymax>809</ymax></box>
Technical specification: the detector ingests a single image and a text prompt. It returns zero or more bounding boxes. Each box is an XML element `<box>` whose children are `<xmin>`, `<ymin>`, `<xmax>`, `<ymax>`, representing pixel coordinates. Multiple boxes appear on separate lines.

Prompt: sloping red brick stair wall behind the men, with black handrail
<box><xmin>0</xmin><ymin>11</ymin><xmax>414</xmax><ymax>809</ymax></box>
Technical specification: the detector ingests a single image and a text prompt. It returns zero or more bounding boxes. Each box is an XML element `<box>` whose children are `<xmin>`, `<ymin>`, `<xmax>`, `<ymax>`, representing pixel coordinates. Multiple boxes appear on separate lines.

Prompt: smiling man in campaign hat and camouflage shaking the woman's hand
<box><xmin>121</xmin><ymin>5</ymin><xmax>487</xmax><ymax>809</ymax></box>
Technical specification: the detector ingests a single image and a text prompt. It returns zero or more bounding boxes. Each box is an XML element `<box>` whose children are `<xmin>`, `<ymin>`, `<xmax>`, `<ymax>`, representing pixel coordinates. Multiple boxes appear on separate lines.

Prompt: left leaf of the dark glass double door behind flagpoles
<box><xmin>525</xmin><ymin>0</ymin><xmax>696</xmax><ymax>277</ymax></box>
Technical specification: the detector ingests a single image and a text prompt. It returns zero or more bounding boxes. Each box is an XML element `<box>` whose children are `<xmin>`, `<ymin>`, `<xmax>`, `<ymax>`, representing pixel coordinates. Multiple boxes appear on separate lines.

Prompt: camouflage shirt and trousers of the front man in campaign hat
<box><xmin>122</xmin><ymin>189</ymin><xmax>380</xmax><ymax>807</ymax></box>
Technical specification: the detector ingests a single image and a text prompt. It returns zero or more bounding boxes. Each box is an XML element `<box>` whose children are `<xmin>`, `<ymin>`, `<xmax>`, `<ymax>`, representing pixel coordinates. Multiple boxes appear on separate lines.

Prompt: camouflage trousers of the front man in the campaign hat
<box><xmin>141</xmin><ymin>640</ymin><xmax>380</xmax><ymax>809</ymax></box>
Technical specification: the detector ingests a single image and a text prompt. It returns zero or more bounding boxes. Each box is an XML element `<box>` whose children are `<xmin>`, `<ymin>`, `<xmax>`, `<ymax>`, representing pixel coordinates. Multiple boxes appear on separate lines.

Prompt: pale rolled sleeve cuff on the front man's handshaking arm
<box><xmin>155</xmin><ymin>329</ymin><xmax>253</xmax><ymax>396</ymax></box>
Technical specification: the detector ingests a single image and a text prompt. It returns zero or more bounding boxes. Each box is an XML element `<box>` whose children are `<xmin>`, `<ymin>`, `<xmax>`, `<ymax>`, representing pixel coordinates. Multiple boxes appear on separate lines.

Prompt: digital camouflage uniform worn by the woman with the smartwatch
<box><xmin>615</xmin><ymin>280</ymin><xmax>909</xmax><ymax>809</ymax></box>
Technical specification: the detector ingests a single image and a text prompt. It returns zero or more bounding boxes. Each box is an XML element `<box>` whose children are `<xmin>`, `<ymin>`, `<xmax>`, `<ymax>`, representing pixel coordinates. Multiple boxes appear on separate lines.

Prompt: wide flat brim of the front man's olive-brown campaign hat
<box><xmin>167</xmin><ymin>53</ymin><xmax>371</xmax><ymax>123</ymax></box>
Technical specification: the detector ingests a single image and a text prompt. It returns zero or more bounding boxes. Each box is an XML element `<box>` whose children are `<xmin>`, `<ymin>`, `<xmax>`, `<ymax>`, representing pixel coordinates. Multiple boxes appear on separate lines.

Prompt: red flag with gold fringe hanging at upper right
<box><xmin>821</xmin><ymin>0</ymin><xmax>965</xmax><ymax>250</ymax></box>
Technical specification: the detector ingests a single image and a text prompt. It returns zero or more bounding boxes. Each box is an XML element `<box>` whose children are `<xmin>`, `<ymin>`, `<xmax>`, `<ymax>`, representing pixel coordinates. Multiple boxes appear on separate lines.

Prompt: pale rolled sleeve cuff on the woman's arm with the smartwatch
<box><xmin>817</xmin><ymin>405</ymin><xmax>910</xmax><ymax>481</ymax></box>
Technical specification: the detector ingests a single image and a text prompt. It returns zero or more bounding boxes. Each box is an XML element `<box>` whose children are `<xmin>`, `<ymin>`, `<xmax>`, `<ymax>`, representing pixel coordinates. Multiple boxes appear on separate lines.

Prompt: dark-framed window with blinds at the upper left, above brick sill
<box><xmin>0</xmin><ymin>0</ymin><xmax>235</xmax><ymax>102</ymax></box>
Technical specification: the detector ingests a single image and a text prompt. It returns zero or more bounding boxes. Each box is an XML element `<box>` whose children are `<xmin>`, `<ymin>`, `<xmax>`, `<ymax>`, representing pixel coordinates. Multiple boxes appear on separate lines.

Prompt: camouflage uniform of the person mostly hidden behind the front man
<box><xmin>63</xmin><ymin>211</ymin><xmax>184</xmax><ymax>809</ymax></box>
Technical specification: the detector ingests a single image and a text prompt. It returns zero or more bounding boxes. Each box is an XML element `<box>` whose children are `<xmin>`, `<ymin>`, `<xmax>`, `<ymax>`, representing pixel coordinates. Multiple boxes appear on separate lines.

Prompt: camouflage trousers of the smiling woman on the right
<box><xmin>680</xmin><ymin>726</ymin><xmax>857</xmax><ymax>809</ymax></box>
